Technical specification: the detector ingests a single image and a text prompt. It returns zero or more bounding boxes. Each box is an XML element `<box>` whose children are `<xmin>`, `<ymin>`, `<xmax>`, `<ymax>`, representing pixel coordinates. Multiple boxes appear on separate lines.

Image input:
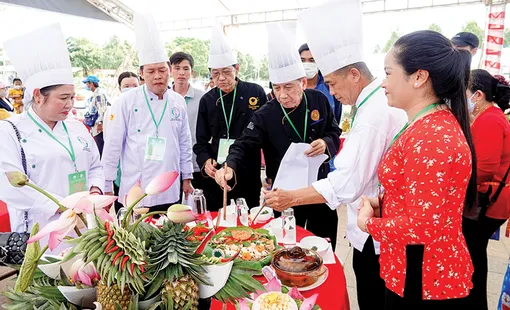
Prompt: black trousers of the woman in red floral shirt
<box><xmin>384</xmin><ymin>245</ymin><xmax>468</xmax><ymax>310</ymax></box>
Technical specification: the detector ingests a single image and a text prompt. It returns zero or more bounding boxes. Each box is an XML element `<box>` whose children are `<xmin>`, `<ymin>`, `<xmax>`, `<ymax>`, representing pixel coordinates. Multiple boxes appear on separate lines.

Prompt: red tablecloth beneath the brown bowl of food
<box><xmin>211</xmin><ymin>214</ymin><xmax>350</xmax><ymax>310</ymax></box>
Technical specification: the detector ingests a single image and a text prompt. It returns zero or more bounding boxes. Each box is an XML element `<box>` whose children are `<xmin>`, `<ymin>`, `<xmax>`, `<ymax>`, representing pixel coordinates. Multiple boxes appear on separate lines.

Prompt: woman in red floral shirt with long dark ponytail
<box><xmin>358</xmin><ymin>31</ymin><xmax>476</xmax><ymax>310</ymax></box>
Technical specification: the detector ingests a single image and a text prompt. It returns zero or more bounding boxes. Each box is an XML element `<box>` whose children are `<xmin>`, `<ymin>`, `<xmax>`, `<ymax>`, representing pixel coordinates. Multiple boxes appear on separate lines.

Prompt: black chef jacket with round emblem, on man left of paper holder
<box><xmin>193</xmin><ymin>79</ymin><xmax>266</xmax><ymax>211</ymax></box>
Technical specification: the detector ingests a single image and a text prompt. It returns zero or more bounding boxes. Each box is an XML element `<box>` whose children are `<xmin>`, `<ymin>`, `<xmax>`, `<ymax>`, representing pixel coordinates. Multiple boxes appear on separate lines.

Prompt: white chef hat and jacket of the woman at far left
<box><xmin>0</xmin><ymin>24</ymin><xmax>104</xmax><ymax>253</ymax></box>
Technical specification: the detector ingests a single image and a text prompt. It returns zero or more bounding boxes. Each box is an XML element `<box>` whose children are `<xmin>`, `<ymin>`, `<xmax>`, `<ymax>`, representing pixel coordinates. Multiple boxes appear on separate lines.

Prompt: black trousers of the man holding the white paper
<box><xmin>294</xmin><ymin>204</ymin><xmax>338</xmax><ymax>251</ymax></box>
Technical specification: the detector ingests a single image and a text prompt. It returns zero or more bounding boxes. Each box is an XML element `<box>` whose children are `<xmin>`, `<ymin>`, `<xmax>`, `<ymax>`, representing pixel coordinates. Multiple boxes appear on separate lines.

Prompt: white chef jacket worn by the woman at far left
<box><xmin>0</xmin><ymin>108</ymin><xmax>104</xmax><ymax>235</ymax></box>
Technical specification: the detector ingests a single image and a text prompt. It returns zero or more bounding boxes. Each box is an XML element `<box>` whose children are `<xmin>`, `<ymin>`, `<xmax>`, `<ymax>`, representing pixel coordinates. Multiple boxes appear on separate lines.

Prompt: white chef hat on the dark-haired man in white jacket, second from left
<box><xmin>133</xmin><ymin>12</ymin><xmax>168</xmax><ymax>66</ymax></box>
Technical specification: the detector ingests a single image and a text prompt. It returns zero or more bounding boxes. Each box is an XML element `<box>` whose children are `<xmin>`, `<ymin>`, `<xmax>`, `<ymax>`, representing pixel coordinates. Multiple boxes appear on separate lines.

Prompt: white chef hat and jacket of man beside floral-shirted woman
<box><xmin>298</xmin><ymin>0</ymin><xmax>407</xmax><ymax>254</ymax></box>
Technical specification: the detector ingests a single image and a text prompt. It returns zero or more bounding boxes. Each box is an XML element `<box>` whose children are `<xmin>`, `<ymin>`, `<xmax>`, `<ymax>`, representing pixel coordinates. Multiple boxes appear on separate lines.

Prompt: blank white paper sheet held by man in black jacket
<box><xmin>273</xmin><ymin>143</ymin><xmax>328</xmax><ymax>190</ymax></box>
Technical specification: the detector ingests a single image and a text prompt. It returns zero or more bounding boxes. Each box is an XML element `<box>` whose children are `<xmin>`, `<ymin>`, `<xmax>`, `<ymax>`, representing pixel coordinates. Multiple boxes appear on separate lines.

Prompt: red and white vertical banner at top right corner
<box><xmin>483</xmin><ymin>4</ymin><xmax>506</xmax><ymax>75</ymax></box>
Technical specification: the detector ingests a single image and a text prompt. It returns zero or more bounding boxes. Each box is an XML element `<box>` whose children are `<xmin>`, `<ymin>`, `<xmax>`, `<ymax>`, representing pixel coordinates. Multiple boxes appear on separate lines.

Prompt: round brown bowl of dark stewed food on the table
<box><xmin>271</xmin><ymin>246</ymin><xmax>327</xmax><ymax>288</ymax></box>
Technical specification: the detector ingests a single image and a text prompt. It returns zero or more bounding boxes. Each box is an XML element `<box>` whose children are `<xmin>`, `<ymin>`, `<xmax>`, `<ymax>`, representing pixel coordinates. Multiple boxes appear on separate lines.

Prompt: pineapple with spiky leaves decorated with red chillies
<box><xmin>64</xmin><ymin>219</ymin><xmax>147</xmax><ymax>310</ymax></box>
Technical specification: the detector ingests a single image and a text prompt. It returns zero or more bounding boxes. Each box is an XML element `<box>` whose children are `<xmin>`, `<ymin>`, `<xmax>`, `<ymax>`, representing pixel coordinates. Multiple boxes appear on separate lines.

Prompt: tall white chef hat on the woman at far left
<box><xmin>3</xmin><ymin>24</ymin><xmax>74</xmax><ymax>104</ymax></box>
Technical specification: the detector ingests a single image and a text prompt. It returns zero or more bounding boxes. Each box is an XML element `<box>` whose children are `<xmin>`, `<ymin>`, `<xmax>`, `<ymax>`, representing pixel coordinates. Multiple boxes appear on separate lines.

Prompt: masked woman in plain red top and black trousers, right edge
<box><xmin>462</xmin><ymin>70</ymin><xmax>510</xmax><ymax>310</ymax></box>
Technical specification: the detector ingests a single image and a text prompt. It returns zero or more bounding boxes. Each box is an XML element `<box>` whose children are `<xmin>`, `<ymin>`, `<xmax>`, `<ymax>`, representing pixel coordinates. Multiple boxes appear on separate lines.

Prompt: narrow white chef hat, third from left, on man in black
<box><xmin>208</xmin><ymin>23</ymin><xmax>237</xmax><ymax>69</ymax></box>
